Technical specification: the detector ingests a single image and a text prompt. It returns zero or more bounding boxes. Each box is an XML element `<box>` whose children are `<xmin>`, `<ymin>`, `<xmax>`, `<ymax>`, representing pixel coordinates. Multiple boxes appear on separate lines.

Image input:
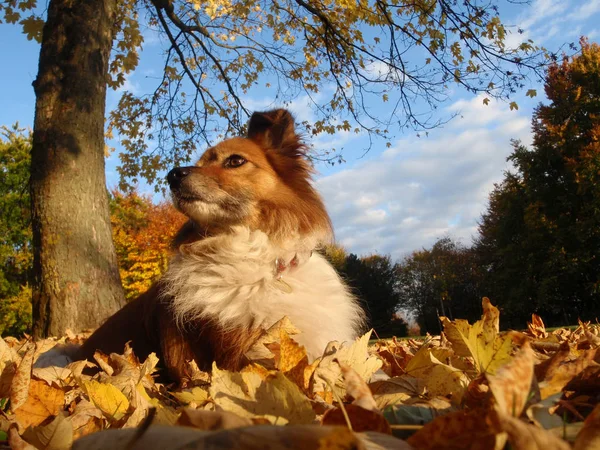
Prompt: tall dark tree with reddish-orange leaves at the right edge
<box><xmin>478</xmin><ymin>40</ymin><xmax>600</xmax><ymax>326</ymax></box>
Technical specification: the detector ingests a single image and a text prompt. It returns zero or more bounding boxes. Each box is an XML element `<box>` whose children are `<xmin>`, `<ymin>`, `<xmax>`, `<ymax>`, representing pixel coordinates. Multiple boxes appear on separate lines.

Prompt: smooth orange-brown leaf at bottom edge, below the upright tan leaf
<box><xmin>491</xmin><ymin>411</ymin><xmax>571</xmax><ymax>450</ymax></box>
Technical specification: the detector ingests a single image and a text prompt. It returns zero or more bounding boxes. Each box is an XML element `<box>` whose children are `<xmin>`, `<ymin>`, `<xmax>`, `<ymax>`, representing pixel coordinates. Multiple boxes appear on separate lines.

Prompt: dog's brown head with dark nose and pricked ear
<box><xmin>167</xmin><ymin>109</ymin><xmax>331</xmax><ymax>248</ymax></box>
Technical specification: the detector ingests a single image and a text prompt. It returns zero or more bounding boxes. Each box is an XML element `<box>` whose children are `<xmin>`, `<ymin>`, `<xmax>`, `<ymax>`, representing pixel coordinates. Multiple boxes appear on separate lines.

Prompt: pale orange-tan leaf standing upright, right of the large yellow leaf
<box><xmin>487</xmin><ymin>342</ymin><xmax>534</xmax><ymax>417</ymax></box>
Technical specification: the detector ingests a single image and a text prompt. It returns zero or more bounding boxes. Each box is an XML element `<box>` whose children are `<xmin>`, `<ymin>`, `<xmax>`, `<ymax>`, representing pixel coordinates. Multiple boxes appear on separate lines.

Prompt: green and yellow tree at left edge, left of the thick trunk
<box><xmin>0</xmin><ymin>124</ymin><xmax>33</xmax><ymax>335</ymax></box>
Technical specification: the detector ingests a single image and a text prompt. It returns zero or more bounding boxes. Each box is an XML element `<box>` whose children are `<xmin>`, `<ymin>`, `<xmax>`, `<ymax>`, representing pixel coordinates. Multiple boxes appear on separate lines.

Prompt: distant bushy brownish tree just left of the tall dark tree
<box><xmin>397</xmin><ymin>236</ymin><xmax>482</xmax><ymax>333</ymax></box>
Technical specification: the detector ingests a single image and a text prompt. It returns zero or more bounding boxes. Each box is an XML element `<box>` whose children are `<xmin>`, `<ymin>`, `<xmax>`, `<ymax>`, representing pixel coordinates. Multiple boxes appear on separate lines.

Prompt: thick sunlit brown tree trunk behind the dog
<box><xmin>31</xmin><ymin>0</ymin><xmax>124</xmax><ymax>337</ymax></box>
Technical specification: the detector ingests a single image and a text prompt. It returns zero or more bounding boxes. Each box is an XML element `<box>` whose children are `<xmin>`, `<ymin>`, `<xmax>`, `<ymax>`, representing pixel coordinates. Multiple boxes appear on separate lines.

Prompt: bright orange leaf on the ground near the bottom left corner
<box><xmin>14</xmin><ymin>380</ymin><xmax>65</xmax><ymax>428</ymax></box>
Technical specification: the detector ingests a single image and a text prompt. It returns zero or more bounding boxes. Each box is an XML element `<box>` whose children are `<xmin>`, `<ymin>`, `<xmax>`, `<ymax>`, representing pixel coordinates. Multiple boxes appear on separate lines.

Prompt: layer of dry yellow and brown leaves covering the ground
<box><xmin>0</xmin><ymin>299</ymin><xmax>600</xmax><ymax>450</ymax></box>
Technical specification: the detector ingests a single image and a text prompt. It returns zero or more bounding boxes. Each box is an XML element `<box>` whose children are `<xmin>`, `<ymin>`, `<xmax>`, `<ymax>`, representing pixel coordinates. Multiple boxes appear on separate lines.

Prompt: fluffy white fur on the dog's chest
<box><xmin>163</xmin><ymin>227</ymin><xmax>364</xmax><ymax>358</ymax></box>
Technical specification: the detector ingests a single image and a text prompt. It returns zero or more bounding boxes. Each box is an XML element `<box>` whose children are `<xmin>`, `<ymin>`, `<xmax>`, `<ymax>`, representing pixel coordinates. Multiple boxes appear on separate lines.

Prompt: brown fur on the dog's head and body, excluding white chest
<box><xmin>78</xmin><ymin>110</ymin><xmax>332</xmax><ymax>380</ymax></box>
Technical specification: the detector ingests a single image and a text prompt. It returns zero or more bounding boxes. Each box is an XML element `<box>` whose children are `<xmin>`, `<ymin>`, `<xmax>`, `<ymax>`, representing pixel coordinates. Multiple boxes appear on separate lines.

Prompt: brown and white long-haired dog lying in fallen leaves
<box><xmin>75</xmin><ymin>109</ymin><xmax>364</xmax><ymax>381</ymax></box>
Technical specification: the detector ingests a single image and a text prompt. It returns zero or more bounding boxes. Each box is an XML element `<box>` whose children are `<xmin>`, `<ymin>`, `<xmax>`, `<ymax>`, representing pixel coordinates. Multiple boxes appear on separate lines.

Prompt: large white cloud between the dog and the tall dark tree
<box><xmin>317</xmin><ymin>97</ymin><xmax>530</xmax><ymax>258</ymax></box>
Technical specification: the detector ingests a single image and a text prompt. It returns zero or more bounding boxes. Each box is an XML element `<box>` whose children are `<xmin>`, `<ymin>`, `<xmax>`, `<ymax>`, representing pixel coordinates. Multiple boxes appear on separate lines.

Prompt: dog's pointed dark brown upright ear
<box><xmin>248</xmin><ymin>109</ymin><xmax>300</xmax><ymax>150</ymax></box>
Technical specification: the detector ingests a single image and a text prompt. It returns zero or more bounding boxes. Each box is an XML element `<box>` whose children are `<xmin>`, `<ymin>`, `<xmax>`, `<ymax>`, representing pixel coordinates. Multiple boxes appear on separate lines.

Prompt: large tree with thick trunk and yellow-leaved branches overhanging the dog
<box><xmin>0</xmin><ymin>0</ymin><xmax>542</xmax><ymax>336</ymax></box>
